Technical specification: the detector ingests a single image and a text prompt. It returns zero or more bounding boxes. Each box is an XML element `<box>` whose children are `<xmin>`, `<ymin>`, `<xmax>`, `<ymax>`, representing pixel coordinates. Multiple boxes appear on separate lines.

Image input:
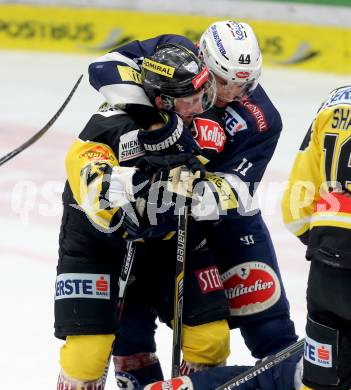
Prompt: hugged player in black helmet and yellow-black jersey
<box><xmin>55</xmin><ymin>45</ymin><xmax>236</xmax><ymax>390</ymax></box>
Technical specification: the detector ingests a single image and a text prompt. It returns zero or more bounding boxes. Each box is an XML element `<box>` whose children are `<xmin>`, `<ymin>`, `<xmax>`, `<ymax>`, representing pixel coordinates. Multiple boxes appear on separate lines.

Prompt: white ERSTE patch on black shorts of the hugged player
<box><xmin>55</xmin><ymin>273</ymin><xmax>110</xmax><ymax>300</ymax></box>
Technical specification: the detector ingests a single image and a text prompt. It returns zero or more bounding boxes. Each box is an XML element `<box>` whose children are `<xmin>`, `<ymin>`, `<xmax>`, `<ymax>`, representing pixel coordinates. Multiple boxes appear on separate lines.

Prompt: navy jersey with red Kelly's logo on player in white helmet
<box><xmin>89</xmin><ymin>34</ymin><xmax>282</xmax><ymax>203</ymax></box>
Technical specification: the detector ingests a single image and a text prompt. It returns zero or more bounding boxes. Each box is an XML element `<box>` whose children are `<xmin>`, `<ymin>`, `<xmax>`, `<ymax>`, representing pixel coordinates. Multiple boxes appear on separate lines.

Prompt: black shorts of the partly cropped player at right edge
<box><xmin>303</xmin><ymin>248</ymin><xmax>351</xmax><ymax>390</ymax></box>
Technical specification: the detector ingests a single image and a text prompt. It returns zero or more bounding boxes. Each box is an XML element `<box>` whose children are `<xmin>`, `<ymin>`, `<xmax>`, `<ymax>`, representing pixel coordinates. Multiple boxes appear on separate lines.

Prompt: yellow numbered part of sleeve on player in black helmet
<box><xmin>66</xmin><ymin>139</ymin><xmax>119</xmax><ymax>229</ymax></box>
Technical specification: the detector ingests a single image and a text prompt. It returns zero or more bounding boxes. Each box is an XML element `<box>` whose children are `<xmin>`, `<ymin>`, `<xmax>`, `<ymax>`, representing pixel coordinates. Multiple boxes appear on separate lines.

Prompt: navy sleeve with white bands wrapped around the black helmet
<box><xmin>88</xmin><ymin>34</ymin><xmax>197</xmax><ymax>105</ymax></box>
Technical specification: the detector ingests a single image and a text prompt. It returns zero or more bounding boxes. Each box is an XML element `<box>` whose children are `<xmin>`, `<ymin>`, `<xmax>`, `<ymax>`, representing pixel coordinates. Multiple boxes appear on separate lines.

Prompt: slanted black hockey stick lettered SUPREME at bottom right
<box><xmin>215</xmin><ymin>339</ymin><xmax>305</xmax><ymax>390</ymax></box>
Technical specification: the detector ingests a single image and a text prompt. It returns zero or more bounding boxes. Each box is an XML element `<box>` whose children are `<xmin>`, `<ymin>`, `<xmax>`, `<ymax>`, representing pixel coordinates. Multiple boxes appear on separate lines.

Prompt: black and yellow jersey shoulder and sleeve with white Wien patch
<box><xmin>64</xmin><ymin>104</ymin><xmax>144</xmax><ymax>231</ymax></box>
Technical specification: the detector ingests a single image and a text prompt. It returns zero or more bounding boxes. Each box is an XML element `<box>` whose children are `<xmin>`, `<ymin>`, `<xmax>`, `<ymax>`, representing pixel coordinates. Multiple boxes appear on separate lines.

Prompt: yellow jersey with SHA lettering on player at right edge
<box><xmin>282</xmin><ymin>86</ymin><xmax>351</xmax><ymax>241</ymax></box>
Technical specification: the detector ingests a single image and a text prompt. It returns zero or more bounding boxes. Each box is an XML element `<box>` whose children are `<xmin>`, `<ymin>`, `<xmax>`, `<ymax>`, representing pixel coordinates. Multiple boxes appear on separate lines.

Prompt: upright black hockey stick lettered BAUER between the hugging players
<box><xmin>172</xmin><ymin>206</ymin><xmax>188</xmax><ymax>378</ymax></box>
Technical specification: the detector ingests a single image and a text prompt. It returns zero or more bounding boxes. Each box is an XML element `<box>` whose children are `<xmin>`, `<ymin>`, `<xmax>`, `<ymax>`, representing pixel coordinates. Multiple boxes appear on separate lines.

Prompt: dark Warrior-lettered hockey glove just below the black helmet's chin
<box><xmin>138</xmin><ymin>112</ymin><xmax>201</xmax><ymax>154</ymax></box>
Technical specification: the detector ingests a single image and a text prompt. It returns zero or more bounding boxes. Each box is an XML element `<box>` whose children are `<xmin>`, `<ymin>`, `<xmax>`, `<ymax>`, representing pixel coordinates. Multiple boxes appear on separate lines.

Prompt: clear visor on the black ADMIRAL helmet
<box><xmin>160</xmin><ymin>72</ymin><xmax>216</xmax><ymax>116</ymax></box>
